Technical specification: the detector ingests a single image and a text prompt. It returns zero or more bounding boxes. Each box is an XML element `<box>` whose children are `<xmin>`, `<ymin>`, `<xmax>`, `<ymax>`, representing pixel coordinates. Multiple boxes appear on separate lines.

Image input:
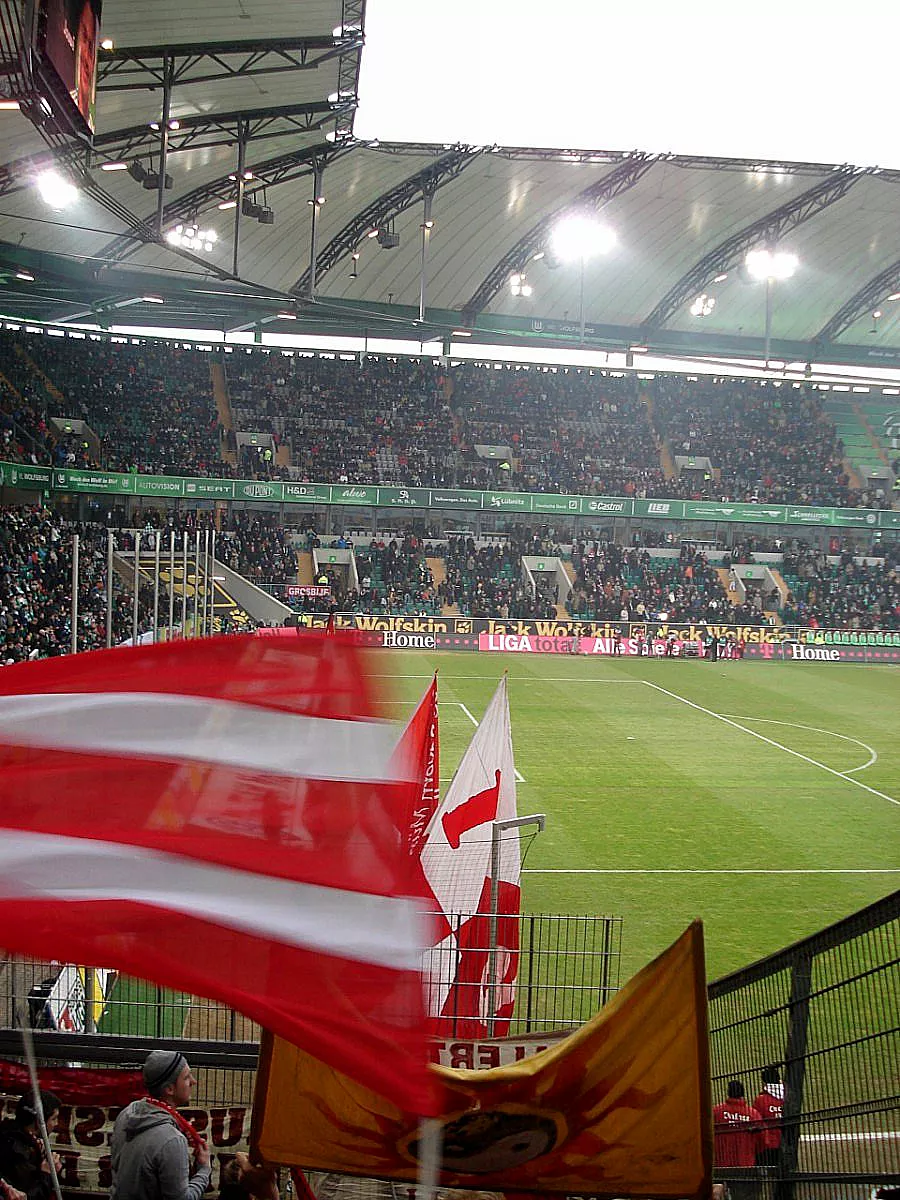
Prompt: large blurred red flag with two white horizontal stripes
<box><xmin>0</xmin><ymin>634</ymin><xmax>433</xmax><ymax>1114</ymax></box>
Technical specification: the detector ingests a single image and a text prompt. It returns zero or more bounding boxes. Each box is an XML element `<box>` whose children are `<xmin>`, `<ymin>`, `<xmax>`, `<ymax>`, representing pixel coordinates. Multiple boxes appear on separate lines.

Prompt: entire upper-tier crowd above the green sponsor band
<box><xmin>0</xmin><ymin>330</ymin><xmax>892</xmax><ymax>508</ymax></box>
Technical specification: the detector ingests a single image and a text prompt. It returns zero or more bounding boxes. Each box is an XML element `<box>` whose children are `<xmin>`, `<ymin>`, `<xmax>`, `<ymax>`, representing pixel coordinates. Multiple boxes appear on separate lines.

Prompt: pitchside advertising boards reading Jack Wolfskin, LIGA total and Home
<box><xmin>273</xmin><ymin>613</ymin><xmax>900</xmax><ymax>664</ymax></box>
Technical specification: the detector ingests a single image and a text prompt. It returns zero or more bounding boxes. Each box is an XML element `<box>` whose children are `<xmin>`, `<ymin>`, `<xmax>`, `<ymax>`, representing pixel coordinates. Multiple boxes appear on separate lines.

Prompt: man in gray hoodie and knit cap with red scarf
<box><xmin>110</xmin><ymin>1050</ymin><xmax>210</xmax><ymax>1200</ymax></box>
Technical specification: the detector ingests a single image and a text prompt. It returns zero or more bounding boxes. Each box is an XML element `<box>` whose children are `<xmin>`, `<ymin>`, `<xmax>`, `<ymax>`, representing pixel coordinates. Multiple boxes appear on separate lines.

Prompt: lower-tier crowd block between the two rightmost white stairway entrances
<box><xmin>568</xmin><ymin>540</ymin><xmax>763</xmax><ymax>624</ymax></box>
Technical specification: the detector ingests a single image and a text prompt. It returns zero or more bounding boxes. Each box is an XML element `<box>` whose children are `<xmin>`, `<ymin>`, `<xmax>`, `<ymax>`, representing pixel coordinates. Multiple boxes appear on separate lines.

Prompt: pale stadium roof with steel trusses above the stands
<box><xmin>0</xmin><ymin>0</ymin><xmax>900</xmax><ymax>366</ymax></box>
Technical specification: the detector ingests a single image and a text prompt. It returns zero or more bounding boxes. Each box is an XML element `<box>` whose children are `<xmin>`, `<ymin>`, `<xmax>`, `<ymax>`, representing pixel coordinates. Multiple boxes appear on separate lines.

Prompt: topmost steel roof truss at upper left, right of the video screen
<box><xmin>97</xmin><ymin>34</ymin><xmax>362</xmax><ymax>91</ymax></box>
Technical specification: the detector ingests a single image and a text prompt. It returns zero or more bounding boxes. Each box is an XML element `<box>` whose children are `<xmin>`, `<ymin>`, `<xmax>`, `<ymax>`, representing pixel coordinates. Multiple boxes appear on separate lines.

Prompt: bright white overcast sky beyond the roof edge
<box><xmin>355</xmin><ymin>0</ymin><xmax>900</xmax><ymax>168</ymax></box>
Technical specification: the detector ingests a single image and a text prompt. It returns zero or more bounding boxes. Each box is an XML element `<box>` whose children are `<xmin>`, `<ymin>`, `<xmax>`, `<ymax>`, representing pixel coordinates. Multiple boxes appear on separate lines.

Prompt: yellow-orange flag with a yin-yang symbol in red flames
<box><xmin>253</xmin><ymin>922</ymin><xmax>712</xmax><ymax>1200</ymax></box>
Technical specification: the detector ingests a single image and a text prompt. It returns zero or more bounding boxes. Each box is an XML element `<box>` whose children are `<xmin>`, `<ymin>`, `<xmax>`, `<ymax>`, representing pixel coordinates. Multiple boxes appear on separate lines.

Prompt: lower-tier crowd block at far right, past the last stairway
<box><xmin>781</xmin><ymin>548</ymin><xmax>900</xmax><ymax>630</ymax></box>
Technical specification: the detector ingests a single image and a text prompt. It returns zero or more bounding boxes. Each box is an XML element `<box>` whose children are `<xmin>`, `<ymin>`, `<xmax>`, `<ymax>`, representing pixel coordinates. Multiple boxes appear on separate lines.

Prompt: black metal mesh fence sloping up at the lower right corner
<box><xmin>709</xmin><ymin>892</ymin><xmax>900</xmax><ymax>1200</ymax></box>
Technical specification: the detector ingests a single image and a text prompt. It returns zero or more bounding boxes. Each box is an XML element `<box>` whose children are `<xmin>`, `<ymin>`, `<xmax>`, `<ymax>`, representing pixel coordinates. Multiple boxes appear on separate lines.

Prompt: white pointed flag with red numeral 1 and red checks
<box><xmin>421</xmin><ymin>676</ymin><xmax>521</xmax><ymax>1038</ymax></box>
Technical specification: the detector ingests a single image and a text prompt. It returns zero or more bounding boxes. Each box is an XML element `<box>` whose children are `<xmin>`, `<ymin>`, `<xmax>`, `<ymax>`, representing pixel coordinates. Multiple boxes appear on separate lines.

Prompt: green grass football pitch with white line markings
<box><xmin>373</xmin><ymin>652</ymin><xmax>900</xmax><ymax>982</ymax></box>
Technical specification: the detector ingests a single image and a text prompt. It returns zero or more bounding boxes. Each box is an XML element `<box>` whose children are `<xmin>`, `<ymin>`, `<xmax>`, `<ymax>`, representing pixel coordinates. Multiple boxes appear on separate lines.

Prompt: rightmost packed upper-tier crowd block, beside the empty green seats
<box><xmin>650</xmin><ymin>376</ymin><xmax>873</xmax><ymax>508</ymax></box>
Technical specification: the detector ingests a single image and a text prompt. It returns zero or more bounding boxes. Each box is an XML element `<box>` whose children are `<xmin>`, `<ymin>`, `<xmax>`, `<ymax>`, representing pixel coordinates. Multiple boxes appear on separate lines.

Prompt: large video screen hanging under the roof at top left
<box><xmin>37</xmin><ymin>0</ymin><xmax>103</xmax><ymax>133</ymax></box>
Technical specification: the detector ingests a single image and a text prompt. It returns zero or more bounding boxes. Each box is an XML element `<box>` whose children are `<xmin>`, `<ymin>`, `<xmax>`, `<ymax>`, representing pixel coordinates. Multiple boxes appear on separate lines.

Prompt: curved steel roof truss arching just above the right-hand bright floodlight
<box><xmin>643</xmin><ymin>167</ymin><xmax>868</xmax><ymax>329</ymax></box>
